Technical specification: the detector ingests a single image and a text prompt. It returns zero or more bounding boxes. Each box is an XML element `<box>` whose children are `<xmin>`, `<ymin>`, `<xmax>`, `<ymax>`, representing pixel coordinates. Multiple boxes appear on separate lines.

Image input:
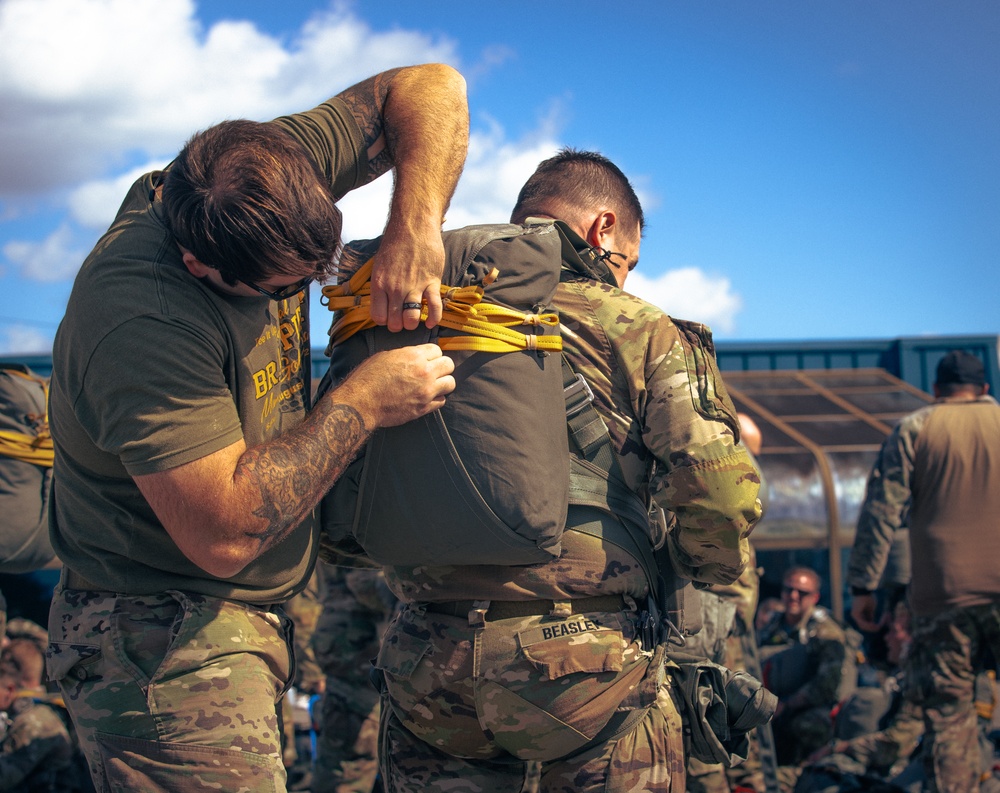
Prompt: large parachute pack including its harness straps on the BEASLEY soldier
<box><xmin>319</xmin><ymin>221</ymin><xmax>701</xmax><ymax>642</ymax></box>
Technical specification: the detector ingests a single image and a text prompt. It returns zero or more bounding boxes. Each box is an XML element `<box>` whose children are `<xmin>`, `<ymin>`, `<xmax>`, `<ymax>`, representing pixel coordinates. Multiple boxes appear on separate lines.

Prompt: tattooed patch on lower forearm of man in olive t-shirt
<box><xmin>236</xmin><ymin>404</ymin><xmax>371</xmax><ymax>550</ymax></box>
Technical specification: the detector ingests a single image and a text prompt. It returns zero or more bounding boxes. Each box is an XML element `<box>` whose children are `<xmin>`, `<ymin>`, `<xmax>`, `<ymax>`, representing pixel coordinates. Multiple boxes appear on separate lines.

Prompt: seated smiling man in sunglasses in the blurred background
<box><xmin>758</xmin><ymin>567</ymin><xmax>857</xmax><ymax>765</ymax></box>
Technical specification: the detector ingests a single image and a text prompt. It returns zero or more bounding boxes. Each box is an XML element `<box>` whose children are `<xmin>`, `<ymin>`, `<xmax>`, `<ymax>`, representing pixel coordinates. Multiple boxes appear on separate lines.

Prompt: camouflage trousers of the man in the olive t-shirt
<box><xmin>47</xmin><ymin>586</ymin><xmax>293</xmax><ymax>793</ymax></box>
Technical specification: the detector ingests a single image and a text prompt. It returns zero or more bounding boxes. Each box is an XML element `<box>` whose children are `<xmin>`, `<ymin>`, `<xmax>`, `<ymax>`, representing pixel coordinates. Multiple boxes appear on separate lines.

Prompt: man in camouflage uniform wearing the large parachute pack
<box><xmin>364</xmin><ymin>150</ymin><xmax>760</xmax><ymax>793</ymax></box>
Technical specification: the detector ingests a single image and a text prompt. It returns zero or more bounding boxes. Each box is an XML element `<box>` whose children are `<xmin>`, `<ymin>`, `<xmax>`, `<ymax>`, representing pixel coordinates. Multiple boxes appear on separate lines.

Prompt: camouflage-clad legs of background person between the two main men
<box><xmin>312</xmin><ymin>562</ymin><xmax>396</xmax><ymax>793</ymax></box>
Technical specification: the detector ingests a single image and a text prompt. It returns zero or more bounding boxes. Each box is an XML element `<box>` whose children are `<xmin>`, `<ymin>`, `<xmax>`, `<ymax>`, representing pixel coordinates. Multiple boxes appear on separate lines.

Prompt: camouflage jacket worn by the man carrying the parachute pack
<box><xmin>386</xmin><ymin>223</ymin><xmax>761</xmax><ymax>601</ymax></box>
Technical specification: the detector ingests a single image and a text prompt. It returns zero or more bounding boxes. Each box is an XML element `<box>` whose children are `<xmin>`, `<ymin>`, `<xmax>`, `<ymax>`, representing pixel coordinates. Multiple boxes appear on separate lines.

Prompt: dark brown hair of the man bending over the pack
<box><xmin>163</xmin><ymin>120</ymin><xmax>342</xmax><ymax>285</ymax></box>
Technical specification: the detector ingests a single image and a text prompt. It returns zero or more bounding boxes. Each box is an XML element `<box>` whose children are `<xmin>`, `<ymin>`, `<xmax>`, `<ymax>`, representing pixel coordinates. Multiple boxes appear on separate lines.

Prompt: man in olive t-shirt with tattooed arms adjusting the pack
<box><xmin>48</xmin><ymin>65</ymin><xmax>468</xmax><ymax>790</ymax></box>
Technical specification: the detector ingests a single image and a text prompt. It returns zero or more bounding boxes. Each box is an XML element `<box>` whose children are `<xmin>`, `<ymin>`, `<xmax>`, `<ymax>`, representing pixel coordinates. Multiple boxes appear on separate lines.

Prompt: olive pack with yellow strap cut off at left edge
<box><xmin>0</xmin><ymin>363</ymin><xmax>55</xmax><ymax>573</ymax></box>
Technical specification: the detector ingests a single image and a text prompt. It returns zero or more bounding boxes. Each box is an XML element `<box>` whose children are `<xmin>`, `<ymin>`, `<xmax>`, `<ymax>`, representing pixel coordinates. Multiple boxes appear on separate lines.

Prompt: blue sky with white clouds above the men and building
<box><xmin>0</xmin><ymin>0</ymin><xmax>1000</xmax><ymax>353</ymax></box>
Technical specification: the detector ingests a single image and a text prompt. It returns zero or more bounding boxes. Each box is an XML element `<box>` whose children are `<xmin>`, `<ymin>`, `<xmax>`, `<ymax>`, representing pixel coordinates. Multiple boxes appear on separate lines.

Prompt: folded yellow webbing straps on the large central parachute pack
<box><xmin>322</xmin><ymin>259</ymin><xmax>562</xmax><ymax>352</ymax></box>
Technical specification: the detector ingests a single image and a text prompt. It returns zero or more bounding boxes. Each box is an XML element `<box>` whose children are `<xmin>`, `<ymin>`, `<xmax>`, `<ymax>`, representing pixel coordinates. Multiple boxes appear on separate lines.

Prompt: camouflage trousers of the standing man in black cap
<box><xmin>910</xmin><ymin>603</ymin><xmax>1000</xmax><ymax>793</ymax></box>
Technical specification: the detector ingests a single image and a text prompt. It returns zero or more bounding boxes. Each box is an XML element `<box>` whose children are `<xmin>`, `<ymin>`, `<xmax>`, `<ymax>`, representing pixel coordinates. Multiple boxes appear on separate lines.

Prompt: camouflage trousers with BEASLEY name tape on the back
<box><xmin>377</xmin><ymin>606</ymin><xmax>684</xmax><ymax>793</ymax></box>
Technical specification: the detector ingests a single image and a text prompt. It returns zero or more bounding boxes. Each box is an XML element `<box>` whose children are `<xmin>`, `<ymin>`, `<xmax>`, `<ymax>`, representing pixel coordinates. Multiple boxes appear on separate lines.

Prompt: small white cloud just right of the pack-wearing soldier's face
<box><xmin>625</xmin><ymin>265</ymin><xmax>743</xmax><ymax>333</ymax></box>
